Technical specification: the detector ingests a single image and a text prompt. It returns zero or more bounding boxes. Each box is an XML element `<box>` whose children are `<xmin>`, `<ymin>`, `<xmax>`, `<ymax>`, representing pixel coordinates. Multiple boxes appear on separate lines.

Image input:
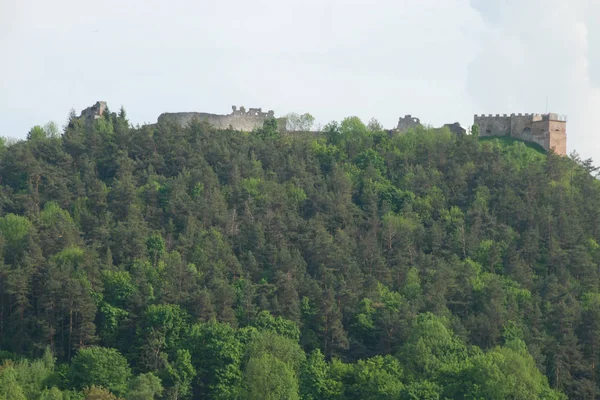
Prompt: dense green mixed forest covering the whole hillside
<box><xmin>0</xmin><ymin>109</ymin><xmax>600</xmax><ymax>400</ymax></box>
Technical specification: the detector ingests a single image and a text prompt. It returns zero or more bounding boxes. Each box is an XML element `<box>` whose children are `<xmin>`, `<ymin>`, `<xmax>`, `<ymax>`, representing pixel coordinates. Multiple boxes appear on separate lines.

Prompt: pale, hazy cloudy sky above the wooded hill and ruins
<box><xmin>0</xmin><ymin>0</ymin><xmax>600</xmax><ymax>163</ymax></box>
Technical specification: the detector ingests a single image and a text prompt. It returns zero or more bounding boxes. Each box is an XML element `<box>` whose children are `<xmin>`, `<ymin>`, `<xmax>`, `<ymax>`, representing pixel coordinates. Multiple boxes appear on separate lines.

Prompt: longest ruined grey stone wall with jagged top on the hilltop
<box><xmin>158</xmin><ymin>106</ymin><xmax>285</xmax><ymax>132</ymax></box>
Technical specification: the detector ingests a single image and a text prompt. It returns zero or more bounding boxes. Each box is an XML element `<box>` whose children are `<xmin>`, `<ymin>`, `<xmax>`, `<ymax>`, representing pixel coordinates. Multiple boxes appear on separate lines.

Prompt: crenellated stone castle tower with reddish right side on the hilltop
<box><xmin>474</xmin><ymin>113</ymin><xmax>567</xmax><ymax>156</ymax></box>
